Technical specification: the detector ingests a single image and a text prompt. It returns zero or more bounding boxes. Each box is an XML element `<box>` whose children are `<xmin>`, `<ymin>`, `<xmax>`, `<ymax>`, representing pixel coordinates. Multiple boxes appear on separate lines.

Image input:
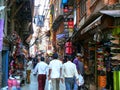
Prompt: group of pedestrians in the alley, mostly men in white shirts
<box><xmin>27</xmin><ymin>52</ymin><xmax>84</xmax><ymax>90</ymax></box>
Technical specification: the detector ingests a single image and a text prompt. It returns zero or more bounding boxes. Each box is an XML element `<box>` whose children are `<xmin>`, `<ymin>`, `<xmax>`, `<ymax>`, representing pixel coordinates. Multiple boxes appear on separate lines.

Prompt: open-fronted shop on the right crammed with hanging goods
<box><xmin>73</xmin><ymin>15</ymin><xmax>120</xmax><ymax>90</ymax></box>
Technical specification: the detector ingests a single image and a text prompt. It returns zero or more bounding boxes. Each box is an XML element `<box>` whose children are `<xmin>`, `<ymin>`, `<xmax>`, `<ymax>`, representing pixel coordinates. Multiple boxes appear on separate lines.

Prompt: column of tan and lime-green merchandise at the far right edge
<box><xmin>110</xmin><ymin>34</ymin><xmax>120</xmax><ymax>90</ymax></box>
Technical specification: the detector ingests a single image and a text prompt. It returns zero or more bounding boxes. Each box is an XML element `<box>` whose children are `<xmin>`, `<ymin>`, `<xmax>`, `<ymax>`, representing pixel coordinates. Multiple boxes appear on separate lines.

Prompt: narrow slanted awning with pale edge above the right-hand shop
<box><xmin>81</xmin><ymin>15</ymin><xmax>102</xmax><ymax>35</ymax></box>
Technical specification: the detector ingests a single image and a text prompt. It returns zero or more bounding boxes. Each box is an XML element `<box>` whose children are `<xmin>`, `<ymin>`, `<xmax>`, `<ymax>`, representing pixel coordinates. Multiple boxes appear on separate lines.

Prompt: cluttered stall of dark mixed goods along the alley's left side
<box><xmin>9</xmin><ymin>32</ymin><xmax>28</xmax><ymax>87</ymax></box>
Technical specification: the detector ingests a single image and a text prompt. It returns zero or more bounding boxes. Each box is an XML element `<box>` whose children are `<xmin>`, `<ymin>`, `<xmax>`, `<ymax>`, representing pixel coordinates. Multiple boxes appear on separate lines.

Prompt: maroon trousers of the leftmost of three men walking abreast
<box><xmin>38</xmin><ymin>74</ymin><xmax>46</xmax><ymax>90</ymax></box>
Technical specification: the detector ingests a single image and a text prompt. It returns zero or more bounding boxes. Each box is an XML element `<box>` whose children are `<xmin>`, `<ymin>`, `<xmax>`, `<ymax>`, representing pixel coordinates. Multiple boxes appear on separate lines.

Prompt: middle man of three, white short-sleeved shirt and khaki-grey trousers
<box><xmin>48</xmin><ymin>53</ymin><xmax>62</xmax><ymax>90</ymax></box>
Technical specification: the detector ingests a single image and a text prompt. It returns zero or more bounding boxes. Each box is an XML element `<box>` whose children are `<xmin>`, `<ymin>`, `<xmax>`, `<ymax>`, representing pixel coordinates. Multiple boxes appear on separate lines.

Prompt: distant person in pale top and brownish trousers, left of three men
<box><xmin>26</xmin><ymin>57</ymin><xmax>33</xmax><ymax>84</ymax></box>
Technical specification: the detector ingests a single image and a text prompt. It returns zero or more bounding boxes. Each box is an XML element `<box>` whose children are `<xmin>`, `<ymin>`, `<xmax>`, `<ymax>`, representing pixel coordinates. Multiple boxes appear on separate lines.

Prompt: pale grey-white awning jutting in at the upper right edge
<box><xmin>100</xmin><ymin>10</ymin><xmax>120</xmax><ymax>17</ymax></box>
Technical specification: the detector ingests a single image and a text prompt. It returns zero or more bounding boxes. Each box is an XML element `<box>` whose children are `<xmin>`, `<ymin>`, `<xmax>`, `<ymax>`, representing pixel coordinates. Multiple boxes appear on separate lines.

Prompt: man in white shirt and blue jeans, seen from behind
<box><xmin>62</xmin><ymin>56</ymin><xmax>79</xmax><ymax>90</ymax></box>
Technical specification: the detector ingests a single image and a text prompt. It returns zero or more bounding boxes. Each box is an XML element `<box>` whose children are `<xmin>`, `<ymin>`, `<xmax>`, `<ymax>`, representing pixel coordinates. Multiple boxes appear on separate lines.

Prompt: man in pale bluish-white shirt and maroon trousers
<box><xmin>34</xmin><ymin>56</ymin><xmax>48</xmax><ymax>90</ymax></box>
